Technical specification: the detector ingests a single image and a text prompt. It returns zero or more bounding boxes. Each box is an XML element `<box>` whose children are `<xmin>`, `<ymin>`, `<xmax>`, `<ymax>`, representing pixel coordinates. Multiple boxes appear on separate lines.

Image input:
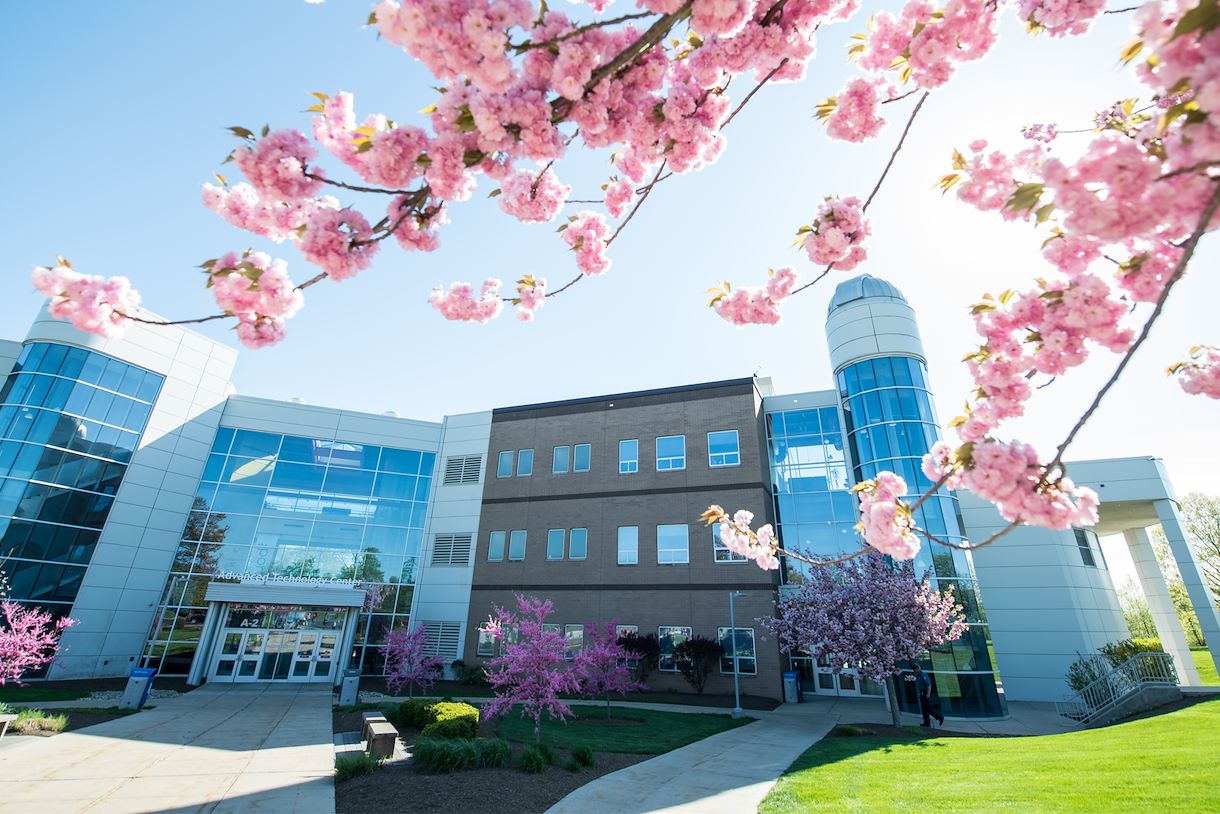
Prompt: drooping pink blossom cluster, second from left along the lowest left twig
<box><xmin>207</xmin><ymin>251</ymin><xmax>305</xmax><ymax>348</ymax></box>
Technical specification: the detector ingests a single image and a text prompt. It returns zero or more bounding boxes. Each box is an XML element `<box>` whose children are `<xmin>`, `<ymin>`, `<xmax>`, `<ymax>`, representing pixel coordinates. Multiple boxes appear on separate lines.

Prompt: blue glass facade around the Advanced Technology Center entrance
<box><xmin>148</xmin><ymin>427</ymin><xmax>436</xmax><ymax>675</ymax></box>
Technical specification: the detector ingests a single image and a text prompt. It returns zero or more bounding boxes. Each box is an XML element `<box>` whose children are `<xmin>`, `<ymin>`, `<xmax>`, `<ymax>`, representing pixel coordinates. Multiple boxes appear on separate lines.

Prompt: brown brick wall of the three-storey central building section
<box><xmin>465</xmin><ymin>378</ymin><xmax>787</xmax><ymax>697</ymax></box>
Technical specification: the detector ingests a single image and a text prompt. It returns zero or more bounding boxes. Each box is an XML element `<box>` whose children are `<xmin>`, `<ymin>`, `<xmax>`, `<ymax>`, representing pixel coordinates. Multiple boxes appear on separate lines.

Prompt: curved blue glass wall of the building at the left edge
<box><xmin>0</xmin><ymin>343</ymin><xmax>163</xmax><ymax>629</ymax></box>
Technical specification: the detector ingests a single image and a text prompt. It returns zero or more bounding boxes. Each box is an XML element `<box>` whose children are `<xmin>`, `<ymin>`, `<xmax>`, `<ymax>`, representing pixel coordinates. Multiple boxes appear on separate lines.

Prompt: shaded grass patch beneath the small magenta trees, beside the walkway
<box><xmin>497</xmin><ymin>707</ymin><xmax>754</xmax><ymax>754</ymax></box>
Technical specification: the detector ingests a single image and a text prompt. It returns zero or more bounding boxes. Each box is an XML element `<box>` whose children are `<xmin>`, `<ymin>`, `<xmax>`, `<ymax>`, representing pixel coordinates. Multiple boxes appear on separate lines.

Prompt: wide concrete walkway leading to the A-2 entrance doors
<box><xmin>0</xmin><ymin>685</ymin><xmax>334</xmax><ymax>814</ymax></box>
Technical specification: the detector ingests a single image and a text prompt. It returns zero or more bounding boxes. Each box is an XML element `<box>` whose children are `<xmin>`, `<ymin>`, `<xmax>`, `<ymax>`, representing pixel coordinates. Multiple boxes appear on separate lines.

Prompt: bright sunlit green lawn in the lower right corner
<box><xmin>759</xmin><ymin>701</ymin><xmax>1220</xmax><ymax>814</ymax></box>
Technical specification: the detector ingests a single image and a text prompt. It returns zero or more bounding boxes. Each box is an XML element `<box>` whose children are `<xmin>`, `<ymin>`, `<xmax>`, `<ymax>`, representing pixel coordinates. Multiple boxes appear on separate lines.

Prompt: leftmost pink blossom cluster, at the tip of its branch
<box><xmin>32</xmin><ymin>258</ymin><xmax>140</xmax><ymax>337</ymax></box>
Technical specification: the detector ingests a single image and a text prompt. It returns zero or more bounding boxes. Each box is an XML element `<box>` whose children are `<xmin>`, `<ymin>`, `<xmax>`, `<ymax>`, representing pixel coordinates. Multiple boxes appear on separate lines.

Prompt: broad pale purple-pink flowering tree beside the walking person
<box><xmin>758</xmin><ymin>552</ymin><xmax>966</xmax><ymax>726</ymax></box>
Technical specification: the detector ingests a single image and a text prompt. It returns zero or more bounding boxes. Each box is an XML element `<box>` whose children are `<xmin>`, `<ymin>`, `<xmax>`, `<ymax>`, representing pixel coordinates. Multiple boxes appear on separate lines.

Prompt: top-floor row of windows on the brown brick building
<box><xmin>495</xmin><ymin>430</ymin><xmax>742</xmax><ymax>477</ymax></box>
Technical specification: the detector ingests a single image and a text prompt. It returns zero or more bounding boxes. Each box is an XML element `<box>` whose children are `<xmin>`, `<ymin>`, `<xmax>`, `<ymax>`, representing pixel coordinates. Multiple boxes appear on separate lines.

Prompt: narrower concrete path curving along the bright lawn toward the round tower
<box><xmin>547</xmin><ymin>696</ymin><xmax>1080</xmax><ymax>814</ymax></box>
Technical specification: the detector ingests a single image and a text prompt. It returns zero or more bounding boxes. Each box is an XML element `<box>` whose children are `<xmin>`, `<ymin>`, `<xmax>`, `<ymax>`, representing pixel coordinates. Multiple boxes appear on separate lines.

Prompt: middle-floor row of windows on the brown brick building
<box><xmin>487</xmin><ymin>524</ymin><xmax>745</xmax><ymax>565</ymax></box>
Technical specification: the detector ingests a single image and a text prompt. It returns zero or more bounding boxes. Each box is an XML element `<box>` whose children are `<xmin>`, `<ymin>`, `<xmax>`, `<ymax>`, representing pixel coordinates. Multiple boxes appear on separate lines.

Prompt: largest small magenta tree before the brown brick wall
<box><xmin>482</xmin><ymin>594</ymin><xmax>581</xmax><ymax>741</ymax></box>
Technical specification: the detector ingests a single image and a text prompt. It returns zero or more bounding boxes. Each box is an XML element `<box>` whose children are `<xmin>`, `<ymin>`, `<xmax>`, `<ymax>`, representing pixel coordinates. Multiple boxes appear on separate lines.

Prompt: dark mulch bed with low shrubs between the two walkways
<box><xmin>334</xmin><ymin>711</ymin><xmax>651</xmax><ymax>814</ymax></box>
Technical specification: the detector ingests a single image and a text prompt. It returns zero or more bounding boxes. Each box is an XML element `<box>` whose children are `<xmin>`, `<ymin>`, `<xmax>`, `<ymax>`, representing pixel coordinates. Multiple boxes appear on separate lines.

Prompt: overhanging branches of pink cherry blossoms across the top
<box><xmin>23</xmin><ymin>0</ymin><xmax>1220</xmax><ymax>567</ymax></box>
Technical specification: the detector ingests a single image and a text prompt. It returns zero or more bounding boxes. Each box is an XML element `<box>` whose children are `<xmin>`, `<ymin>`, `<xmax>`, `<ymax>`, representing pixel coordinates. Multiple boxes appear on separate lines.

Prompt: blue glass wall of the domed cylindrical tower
<box><xmin>837</xmin><ymin>356</ymin><xmax>1008</xmax><ymax>718</ymax></box>
